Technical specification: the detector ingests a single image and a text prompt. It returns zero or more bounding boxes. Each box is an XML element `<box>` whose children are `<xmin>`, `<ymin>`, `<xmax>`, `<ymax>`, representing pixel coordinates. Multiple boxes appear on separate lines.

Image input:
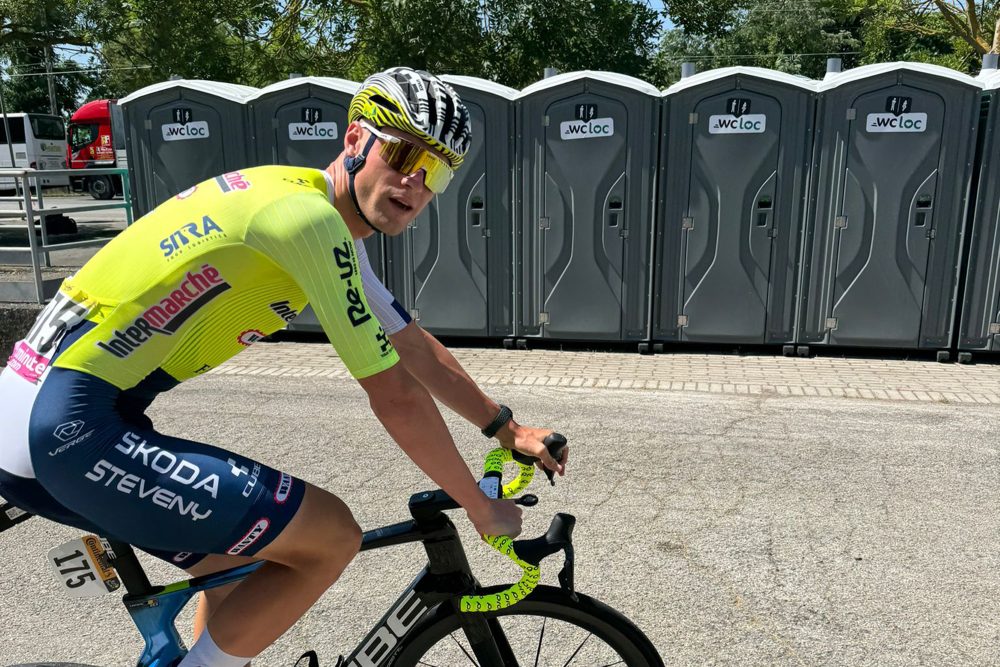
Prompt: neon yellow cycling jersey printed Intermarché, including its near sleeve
<box><xmin>46</xmin><ymin>166</ymin><xmax>399</xmax><ymax>389</ymax></box>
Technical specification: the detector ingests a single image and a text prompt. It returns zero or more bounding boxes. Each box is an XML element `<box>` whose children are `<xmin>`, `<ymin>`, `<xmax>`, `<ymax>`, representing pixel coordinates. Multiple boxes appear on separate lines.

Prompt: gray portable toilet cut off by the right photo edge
<box><xmin>958</xmin><ymin>70</ymin><xmax>1000</xmax><ymax>362</ymax></box>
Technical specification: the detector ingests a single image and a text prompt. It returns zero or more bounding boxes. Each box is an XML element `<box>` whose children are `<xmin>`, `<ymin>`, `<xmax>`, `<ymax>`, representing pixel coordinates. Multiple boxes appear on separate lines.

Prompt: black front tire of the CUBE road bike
<box><xmin>390</xmin><ymin>586</ymin><xmax>663</xmax><ymax>667</ymax></box>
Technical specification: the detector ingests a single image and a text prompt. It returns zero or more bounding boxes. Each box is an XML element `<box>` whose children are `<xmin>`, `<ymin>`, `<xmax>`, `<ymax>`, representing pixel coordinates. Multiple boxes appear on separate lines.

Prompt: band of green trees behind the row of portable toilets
<box><xmin>0</xmin><ymin>0</ymin><xmax>1000</xmax><ymax>113</ymax></box>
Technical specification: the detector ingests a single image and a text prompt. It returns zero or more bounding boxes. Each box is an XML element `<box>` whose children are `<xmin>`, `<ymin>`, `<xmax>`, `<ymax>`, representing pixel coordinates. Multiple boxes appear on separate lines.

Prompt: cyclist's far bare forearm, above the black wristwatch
<box><xmin>392</xmin><ymin>324</ymin><xmax>500</xmax><ymax>428</ymax></box>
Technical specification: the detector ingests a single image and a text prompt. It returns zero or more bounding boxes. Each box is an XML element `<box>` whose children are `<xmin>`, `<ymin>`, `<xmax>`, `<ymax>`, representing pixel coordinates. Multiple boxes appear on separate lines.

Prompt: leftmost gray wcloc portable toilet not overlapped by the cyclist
<box><xmin>516</xmin><ymin>71</ymin><xmax>660</xmax><ymax>342</ymax></box>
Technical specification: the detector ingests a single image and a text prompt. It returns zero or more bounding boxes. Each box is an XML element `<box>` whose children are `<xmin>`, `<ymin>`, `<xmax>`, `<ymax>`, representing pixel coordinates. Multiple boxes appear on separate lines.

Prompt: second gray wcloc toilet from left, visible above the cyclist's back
<box><xmin>246</xmin><ymin>76</ymin><xmax>359</xmax><ymax>169</ymax></box>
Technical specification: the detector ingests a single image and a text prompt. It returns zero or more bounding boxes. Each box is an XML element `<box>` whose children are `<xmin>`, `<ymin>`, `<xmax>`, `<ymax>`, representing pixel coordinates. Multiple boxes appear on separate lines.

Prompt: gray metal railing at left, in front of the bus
<box><xmin>0</xmin><ymin>168</ymin><xmax>132</xmax><ymax>303</ymax></box>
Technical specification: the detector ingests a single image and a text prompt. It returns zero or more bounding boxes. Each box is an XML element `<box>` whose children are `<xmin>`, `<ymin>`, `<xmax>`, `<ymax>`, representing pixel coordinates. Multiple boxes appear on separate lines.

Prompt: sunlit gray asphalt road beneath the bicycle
<box><xmin>0</xmin><ymin>375</ymin><xmax>1000</xmax><ymax>666</ymax></box>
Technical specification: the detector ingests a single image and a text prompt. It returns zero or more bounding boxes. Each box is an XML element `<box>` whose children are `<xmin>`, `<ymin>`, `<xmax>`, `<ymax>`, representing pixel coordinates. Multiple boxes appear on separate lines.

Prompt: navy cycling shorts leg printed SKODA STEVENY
<box><xmin>30</xmin><ymin>368</ymin><xmax>305</xmax><ymax>567</ymax></box>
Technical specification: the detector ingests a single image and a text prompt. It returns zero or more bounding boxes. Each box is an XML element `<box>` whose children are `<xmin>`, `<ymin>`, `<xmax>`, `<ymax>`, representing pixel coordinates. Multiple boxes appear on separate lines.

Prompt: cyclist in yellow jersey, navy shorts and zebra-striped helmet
<box><xmin>0</xmin><ymin>68</ymin><xmax>564</xmax><ymax>667</ymax></box>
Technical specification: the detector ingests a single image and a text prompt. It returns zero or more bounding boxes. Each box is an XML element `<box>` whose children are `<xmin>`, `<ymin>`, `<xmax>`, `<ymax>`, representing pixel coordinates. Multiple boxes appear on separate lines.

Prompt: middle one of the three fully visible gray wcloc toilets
<box><xmin>652</xmin><ymin>67</ymin><xmax>816</xmax><ymax>344</ymax></box>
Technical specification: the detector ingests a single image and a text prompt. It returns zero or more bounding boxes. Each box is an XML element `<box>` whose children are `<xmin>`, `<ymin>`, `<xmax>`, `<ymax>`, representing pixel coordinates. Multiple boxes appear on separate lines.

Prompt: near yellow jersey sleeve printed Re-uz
<box><xmin>245</xmin><ymin>194</ymin><xmax>399</xmax><ymax>379</ymax></box>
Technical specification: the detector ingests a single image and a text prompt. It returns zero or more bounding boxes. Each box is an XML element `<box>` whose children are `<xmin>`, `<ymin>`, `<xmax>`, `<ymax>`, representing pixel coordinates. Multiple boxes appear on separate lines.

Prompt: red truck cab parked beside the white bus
<box><xmin>66</xmin><ymin>100</ymin><xmax>124</xmax><ymax>199</ymax></box>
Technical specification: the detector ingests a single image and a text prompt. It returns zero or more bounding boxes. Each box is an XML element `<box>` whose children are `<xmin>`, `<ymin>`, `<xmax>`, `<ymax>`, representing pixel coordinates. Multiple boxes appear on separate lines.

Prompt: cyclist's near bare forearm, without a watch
<box><xmin>371</xmin><ymin>380</ymin><xmax>487</xmax><ymax>514</ymax></box>
